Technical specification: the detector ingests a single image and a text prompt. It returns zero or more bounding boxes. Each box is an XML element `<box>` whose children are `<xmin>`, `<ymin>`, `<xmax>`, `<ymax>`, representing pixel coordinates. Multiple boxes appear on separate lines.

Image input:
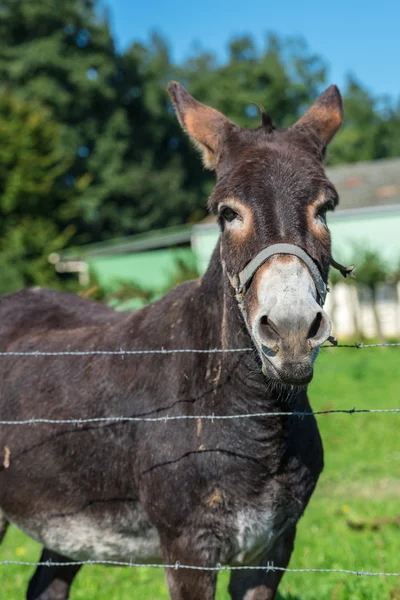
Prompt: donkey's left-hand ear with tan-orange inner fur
<box><xmin>167</xmin><ymin>81</ymin><xmax>237</xmax><ymax>170</ymax></box>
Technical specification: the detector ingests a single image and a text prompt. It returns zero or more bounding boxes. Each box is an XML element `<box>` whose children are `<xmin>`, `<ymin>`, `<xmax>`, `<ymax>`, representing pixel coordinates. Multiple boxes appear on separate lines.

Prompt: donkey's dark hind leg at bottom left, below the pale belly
<box><xmin>26</xmin><ymin>548</ymin><xmax>81</xmax><ymax>600</ymax></box>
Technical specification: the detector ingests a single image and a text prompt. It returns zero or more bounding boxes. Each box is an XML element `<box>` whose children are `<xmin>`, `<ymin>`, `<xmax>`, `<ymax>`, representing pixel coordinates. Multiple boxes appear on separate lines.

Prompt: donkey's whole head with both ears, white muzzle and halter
<box><xmin>168</xmin><ymin>82</ymin><xmax>342</xmax><ymax>385</ymax></box>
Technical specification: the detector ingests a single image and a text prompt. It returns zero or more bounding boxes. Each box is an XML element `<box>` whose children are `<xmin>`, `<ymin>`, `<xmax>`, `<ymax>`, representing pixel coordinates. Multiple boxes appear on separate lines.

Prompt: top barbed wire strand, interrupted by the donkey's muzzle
<box><xmin>0</xmin><ymin>342</ymin><xmax>400</xmax><ymax>357</ymax></box>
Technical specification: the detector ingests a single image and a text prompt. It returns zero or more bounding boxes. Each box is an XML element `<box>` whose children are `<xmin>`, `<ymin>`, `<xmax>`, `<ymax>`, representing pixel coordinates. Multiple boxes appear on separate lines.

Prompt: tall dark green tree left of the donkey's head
<box><xmin>0</xmin><ymin>0</ymin><xmax>209</xmax><ymax>244</ymax></box>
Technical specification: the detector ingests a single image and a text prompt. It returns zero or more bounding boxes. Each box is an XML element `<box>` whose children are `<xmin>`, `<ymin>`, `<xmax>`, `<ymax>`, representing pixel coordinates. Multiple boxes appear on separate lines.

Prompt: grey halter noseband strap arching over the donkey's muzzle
<box><xmin>235</xmin><ymin>244</ymin><xmax>328</xmax><ymax>306</ymax></box>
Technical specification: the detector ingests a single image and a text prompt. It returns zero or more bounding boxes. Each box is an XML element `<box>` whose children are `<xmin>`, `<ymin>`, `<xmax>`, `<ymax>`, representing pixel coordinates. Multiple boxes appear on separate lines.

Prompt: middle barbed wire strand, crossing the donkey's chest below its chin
<box><xmin>0</xmin><ymin>407</ymin><xmax>400</xmax><ymax>425</ymax></box>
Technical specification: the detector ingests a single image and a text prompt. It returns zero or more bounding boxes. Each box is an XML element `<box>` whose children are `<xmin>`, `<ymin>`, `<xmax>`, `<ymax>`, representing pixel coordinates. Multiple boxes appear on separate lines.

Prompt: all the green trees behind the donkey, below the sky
<box><xmin>0</xmin><ymin>0</ymin><xmax>400</xmax><ymax>293</ymax></box>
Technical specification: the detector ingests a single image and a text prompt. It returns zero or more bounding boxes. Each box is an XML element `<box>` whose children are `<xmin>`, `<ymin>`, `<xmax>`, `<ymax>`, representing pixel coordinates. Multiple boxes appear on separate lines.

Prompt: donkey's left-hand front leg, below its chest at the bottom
<box><xmin>162</xmin><ymin>536</ymin><xmax>218</xmax><ymax>600</ymax></box>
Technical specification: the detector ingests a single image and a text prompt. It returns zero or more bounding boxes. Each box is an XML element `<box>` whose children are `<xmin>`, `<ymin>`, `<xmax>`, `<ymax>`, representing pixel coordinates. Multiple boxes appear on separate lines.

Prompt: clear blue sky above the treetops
<box><xmin>105</xmin><ymin>0</ymin><xmax>400</xmax><ymax>99</ymax></box>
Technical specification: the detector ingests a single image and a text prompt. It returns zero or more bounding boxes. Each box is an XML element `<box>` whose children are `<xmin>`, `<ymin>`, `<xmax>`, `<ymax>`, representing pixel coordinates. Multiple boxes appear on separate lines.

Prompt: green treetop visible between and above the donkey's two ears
<box><xmin>182</xmin><ymin>34</ymin><xmax>326</xmax><ymax>127</ymax></box>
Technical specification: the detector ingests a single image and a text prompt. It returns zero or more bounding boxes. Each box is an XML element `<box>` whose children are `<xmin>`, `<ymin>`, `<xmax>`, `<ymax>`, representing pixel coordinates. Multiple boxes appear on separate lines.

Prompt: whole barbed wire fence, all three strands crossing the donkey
<box><xmin>0</xmin><ymin>342</ymin><xmax>400</xmax><ymax>578</ymax></box>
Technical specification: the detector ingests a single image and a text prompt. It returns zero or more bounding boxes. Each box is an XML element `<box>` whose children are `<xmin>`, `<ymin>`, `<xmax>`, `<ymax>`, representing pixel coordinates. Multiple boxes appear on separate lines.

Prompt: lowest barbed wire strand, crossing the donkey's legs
<box><xmin>0</xmin><ymin>560</ymin><xmax>400</xmax><ymax>577</ymax></box>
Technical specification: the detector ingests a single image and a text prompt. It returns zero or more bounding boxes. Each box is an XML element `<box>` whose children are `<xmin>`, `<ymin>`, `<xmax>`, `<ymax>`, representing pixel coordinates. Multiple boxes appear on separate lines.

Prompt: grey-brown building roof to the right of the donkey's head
<box><xmin>326</xmin><ymin>158</ymin><xmax>400</xmax><ymax>211</ymax></box>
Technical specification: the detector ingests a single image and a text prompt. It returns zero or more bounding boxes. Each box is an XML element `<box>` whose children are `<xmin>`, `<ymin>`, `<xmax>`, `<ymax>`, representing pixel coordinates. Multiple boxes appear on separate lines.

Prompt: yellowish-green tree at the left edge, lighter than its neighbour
<box><xmin>0</xmin><ymin>93</ymin><xmax>73</xmax><ymax>293</ymax></box>
